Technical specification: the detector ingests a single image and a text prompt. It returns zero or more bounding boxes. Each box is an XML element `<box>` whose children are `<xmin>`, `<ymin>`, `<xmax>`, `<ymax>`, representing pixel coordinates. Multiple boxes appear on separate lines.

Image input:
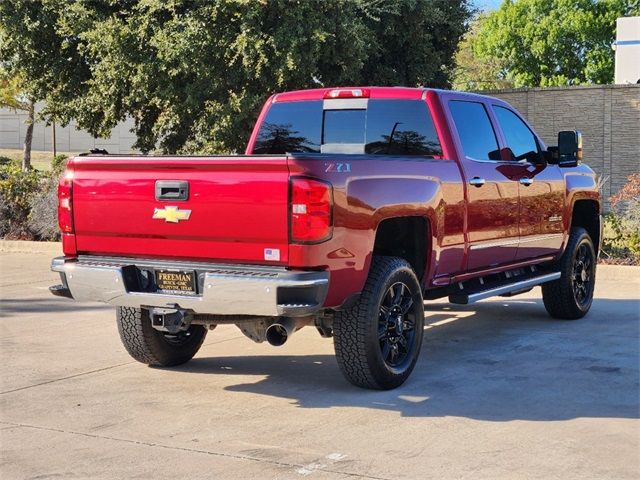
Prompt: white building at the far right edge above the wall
<box><xmin>613</xmin><ymin>17</ymin><xmax>640</xmax><ymax>85</ymax></box>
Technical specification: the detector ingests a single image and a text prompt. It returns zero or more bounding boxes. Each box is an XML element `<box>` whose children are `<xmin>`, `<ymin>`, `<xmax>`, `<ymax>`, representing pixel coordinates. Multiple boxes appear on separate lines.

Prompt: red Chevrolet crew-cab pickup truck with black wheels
<box><xmin>51</xmin><ymin>87</ymin><xmax>601</xmax><ymax>389</ymax></box>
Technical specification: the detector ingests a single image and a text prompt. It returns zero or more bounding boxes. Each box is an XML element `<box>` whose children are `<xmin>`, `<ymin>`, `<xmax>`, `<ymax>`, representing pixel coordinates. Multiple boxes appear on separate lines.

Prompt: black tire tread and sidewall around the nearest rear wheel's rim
<box><xmin>333</xmin><ymin>256</ymin><xmax>424</xmax><ymax>390</ymax></box>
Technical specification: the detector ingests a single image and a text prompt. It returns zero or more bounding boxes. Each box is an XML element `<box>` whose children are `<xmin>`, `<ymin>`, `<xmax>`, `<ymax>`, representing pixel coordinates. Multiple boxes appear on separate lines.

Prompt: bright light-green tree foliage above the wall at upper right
<box><xmin>455</xmin><ymin>0</ymin><xmax>640</xmax><ymax>89</ymax></box>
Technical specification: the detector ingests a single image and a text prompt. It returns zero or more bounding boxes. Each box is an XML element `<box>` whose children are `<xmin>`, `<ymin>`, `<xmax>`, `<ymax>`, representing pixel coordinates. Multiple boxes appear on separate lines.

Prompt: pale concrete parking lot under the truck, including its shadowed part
<box><xmin>0</xmin><ymin>252</ymin><xmax>640</xmax><ymax>480</ymax></box>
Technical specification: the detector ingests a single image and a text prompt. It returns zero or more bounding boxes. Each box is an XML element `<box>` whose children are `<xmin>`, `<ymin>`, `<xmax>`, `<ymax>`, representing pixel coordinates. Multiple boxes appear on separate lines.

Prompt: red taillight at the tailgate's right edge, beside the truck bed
<box><xmin>289</xmin><ymin>178</ymin><xmax>333</xmax><ymax>243</ymax></box>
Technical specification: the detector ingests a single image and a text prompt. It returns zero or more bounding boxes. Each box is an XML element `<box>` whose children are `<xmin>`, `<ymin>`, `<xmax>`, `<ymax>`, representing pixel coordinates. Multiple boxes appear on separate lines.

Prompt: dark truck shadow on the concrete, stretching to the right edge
<box><xmin>175</xmin><ymin>299</ymin><xmax>640</xmax><ymax>421</ymax></box>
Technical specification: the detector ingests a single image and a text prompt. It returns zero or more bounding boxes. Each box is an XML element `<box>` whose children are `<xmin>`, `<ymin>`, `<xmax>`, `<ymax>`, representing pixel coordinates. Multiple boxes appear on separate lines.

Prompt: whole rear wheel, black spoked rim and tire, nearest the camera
<box><xmin>333</xmin><ymin>257</ymin><xmax>424</xmax><ymax>390</ymax></box>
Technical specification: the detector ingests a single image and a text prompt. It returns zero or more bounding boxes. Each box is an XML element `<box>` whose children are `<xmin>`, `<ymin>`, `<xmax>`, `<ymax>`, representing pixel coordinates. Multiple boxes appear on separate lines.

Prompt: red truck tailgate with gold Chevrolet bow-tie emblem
<box><xmin>73</xmin><ymin>156</ymin><xmax>289</xmax><ymax>264</ymax></box>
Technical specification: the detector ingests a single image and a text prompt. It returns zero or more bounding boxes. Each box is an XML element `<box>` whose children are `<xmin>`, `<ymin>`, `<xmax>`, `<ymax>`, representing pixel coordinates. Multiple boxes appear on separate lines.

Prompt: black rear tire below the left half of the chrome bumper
<box><xmin>116</xmin><ymin>307</ymin><xmax>207</xmax><ymax>367</ymax></box>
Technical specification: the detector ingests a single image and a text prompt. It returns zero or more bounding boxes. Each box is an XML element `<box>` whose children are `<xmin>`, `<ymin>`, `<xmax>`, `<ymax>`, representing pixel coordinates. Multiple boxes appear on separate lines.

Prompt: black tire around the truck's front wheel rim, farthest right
<box><xmin>542</xmin><ymin>227</ymin><xmax>597</xmax><ymax>320</ymax></box>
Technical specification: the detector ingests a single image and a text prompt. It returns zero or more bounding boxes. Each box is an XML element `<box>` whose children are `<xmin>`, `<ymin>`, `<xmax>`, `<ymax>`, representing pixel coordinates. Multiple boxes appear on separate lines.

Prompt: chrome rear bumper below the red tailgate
<box><xmin>51</xmin><ymin>256</ymin><xmax>329</xmax><ymax>317</ymax></box>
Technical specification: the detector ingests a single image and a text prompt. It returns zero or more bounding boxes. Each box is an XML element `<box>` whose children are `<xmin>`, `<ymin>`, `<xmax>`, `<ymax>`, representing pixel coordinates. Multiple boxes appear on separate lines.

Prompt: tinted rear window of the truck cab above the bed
<box><xmin>253</xmin><ymin>100</ymin><xmax>442</xmax><ymax>157</ymax></box>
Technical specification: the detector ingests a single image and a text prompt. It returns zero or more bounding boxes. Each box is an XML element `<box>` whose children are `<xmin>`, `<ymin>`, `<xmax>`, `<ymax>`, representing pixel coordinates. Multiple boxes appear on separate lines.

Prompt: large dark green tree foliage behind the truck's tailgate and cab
<box><xmin>0</xmin><ymin>0</ymin><xmax>470</xmax><ymax>152</ymax></box>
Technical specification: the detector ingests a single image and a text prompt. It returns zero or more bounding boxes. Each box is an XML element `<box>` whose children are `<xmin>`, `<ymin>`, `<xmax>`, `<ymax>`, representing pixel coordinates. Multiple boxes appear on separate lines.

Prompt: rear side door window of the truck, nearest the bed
<box><xmin>449</xmin><ymin>100</ymin><xmax>501</xmax><ymax>160</ymax></box>
